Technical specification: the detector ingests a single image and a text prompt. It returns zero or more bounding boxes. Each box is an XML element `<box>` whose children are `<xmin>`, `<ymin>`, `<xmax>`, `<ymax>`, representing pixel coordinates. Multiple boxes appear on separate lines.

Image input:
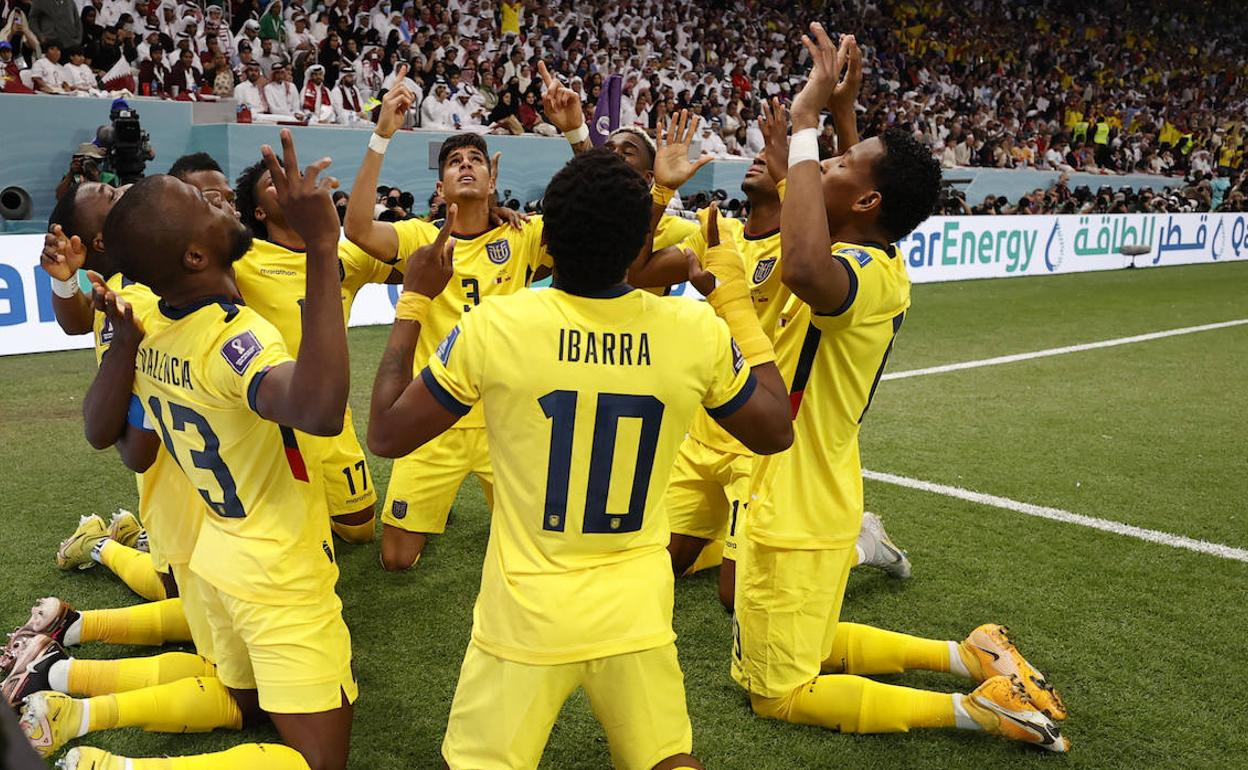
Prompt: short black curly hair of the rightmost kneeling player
<box><xmin>871</xmin><ymin>127</ymin><xmax>941</xmax><ymax>242</ymax></box>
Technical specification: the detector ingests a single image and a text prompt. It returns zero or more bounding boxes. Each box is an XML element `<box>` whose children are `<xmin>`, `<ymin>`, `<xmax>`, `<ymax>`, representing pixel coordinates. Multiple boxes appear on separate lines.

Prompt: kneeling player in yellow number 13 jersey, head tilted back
<box><xmin>21</xmin><ymin>131</ymin><xmax>357</xmax><ymax>770</ymax></box>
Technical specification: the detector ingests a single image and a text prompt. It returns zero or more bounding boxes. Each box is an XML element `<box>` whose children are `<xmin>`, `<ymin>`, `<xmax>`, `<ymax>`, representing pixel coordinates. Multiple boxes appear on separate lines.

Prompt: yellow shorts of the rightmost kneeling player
<box><xmin>733</xmin><ymin>538</ymin><xmax>857</xmax><ymax>698</ymax></box>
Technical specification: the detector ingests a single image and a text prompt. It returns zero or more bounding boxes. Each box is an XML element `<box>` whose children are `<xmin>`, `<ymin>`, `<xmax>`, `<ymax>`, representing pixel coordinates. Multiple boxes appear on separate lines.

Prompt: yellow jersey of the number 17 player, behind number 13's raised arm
<box><xmin>233</xmin><ymin>238</ymin><xmax>393</xmax><ymax>354</ymax></box>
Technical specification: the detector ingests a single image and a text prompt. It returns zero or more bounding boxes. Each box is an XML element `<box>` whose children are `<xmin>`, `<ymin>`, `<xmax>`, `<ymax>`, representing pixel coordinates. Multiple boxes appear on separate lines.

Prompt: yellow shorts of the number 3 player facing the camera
<box><xmin>382</xmin><ymin>428</ymin><xmax>494</xmax><ymax>534</ymax></box>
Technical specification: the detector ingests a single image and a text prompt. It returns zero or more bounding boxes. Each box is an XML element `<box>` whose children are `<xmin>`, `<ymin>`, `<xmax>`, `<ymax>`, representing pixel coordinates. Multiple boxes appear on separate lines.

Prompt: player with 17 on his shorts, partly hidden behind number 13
<box><xmin>233</xmin><ymin>152</ymin><xmax>403</xmax><ymax>543</ymax></box>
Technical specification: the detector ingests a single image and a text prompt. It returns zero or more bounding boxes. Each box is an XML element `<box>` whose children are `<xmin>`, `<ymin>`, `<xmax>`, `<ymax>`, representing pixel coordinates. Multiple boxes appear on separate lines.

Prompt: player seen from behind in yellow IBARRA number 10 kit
<box><xmin>368</xmin><ymin>150</ymin><xmax>791</xmax><ymax>770</ymax></box>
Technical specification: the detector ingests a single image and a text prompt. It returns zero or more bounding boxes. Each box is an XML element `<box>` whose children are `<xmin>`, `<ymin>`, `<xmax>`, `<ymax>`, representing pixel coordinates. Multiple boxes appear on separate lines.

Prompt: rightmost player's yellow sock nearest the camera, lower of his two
<box><xmin>751</xmin><ymin>674</ymin><xmax>957</xmax><ymax>733</ymax></box>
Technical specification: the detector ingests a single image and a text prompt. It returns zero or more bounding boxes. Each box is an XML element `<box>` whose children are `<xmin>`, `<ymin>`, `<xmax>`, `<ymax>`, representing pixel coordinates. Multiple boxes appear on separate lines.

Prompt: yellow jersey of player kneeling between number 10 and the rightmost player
<box><xmin>685</xmin><ymin>208</ymin><xmax>791</xmax><ymax>454</ymax></box>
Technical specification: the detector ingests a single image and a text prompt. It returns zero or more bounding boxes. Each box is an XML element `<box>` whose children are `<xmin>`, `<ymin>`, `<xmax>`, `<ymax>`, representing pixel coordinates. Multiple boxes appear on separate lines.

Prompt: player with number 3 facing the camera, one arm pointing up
<box><xmin>343</xmin><ymin>65</ymin><xmax>549</xmax><ymax>570</ymax></box>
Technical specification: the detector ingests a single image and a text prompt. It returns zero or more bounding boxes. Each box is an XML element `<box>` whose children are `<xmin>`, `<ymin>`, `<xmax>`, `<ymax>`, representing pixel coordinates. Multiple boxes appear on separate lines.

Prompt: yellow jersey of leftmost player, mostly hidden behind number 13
<box><xmin>94</xmin><ymin>273</ymin><xmax>203</xmax><ymax>569</ymax></box>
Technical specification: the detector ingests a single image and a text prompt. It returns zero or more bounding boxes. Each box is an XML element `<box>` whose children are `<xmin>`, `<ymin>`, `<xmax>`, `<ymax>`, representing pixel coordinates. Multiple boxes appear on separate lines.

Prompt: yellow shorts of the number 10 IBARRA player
<box><xmin>442</xmin><ymin>643</ymin><xmax>693</xmax><ymax>770</ymax></box>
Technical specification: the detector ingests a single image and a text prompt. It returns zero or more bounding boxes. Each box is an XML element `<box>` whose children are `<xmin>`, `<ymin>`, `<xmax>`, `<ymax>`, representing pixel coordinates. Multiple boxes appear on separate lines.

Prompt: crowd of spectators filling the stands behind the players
<box><xmin>0</xmin><ymin>0</ymin><xmax>1248</xmax><ymax>178</ymax></box>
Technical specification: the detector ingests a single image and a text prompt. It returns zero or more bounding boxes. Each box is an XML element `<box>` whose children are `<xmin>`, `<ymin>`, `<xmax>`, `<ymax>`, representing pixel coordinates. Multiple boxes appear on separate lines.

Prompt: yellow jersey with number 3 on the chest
<box><xmin>394</xmin><ymin>216</ymin><xmax>552</xmax><ymax>428</ymax></box>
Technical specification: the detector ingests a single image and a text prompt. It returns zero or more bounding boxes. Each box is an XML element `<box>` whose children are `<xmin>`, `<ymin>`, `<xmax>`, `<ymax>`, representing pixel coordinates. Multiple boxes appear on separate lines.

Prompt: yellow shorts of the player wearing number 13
<box><xmin>194</xmin><ymin>582</ymin><xmax>359</xmax><ymax>714</ymax></box>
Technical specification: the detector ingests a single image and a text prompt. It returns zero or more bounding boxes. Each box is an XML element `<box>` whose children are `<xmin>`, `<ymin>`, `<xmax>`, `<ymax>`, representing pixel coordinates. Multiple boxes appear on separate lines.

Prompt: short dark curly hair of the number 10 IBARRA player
<box><xmin>543</xmin><ymin>147</ymin><xmax>650</xmax><ymax>293</ymax></box>
